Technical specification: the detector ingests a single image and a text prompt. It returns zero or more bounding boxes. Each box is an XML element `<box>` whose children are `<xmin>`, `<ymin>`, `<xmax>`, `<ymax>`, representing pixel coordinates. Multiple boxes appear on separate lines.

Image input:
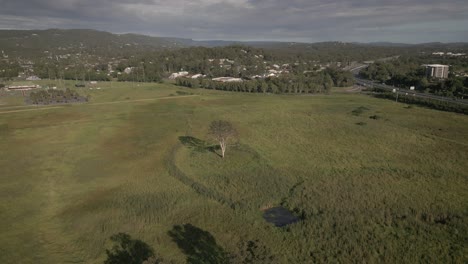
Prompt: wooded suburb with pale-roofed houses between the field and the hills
<box><xmin>24</xmin><ymin>46</ymin><xmax>353</xmax><ymax>86</ymax></box>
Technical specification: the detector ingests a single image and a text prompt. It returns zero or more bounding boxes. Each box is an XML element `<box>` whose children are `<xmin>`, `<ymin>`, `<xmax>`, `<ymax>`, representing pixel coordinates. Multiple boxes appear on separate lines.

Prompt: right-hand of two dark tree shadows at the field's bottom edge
<box><xmin>168</xmin><ymin>224</ymin><xmax>229</xmax><ymax>264</ymax></box>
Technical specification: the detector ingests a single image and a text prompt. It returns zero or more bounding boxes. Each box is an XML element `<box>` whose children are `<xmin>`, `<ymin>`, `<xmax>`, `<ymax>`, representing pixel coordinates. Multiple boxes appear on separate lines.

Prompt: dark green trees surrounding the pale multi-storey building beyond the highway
<box><xmin>360</xmin><ymin>56</ymin><xmax>468</xmax><ymax>98</ymax></box>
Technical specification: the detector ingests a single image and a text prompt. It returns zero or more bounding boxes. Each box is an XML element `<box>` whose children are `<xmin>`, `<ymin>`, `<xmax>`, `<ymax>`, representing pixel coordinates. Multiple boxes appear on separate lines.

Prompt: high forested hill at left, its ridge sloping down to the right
<box><xmin>0</xmin><ymin>29</ymin><xmax>188</xmax><ymax>57</ymax></box>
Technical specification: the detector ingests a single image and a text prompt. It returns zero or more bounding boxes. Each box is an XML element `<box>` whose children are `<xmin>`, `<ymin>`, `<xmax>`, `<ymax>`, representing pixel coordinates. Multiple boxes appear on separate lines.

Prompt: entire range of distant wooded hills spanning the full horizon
<box><xmin>0</xmin><ymin>29</ymin><xmax>468</xmax><ymax>60</ymax></box>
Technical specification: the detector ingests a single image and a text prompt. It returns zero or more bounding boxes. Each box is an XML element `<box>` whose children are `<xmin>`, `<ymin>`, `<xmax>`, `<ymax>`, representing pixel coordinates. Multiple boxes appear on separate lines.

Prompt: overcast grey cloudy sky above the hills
<box><xmin>0</xmin><ymin>0</ymin><xmax>468</xmax><ymax>43</ymax></box>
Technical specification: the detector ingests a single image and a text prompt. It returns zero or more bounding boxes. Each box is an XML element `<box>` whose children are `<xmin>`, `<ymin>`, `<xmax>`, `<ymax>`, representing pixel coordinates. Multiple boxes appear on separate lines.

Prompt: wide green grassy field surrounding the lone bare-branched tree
<box><xmin>0</xmin><ymin>83</ymin><xmax>468</xmax><ymax>263</ymax></box>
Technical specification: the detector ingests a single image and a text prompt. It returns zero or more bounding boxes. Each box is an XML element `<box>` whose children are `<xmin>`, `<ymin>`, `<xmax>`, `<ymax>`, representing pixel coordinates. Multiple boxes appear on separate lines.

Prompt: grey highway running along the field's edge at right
<box><xmin>350</xmin><ymin>65</ymin><xmax>468</xmax><ymax>106</ymax></box>
